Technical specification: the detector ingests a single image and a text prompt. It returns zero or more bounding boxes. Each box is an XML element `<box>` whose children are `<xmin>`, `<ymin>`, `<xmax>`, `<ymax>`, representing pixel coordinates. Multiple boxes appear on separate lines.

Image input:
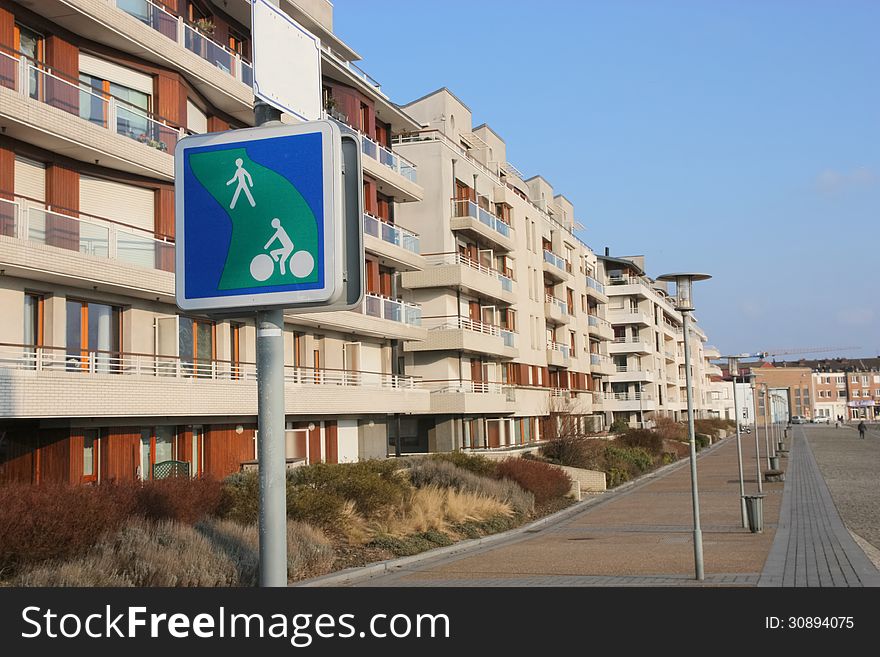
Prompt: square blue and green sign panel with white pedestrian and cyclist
<box><xmin>175</xmin><ymin>121</ymin><xmax>363</xmax><ymax>312</ymax></box>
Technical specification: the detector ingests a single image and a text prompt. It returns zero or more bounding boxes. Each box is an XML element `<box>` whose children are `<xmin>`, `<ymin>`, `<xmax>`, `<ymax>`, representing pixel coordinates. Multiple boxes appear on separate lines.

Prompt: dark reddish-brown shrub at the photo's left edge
<box><xmin>0</xmin><ymin>484</ymin><xmax>138</xmax><ymax>575</ymax></box>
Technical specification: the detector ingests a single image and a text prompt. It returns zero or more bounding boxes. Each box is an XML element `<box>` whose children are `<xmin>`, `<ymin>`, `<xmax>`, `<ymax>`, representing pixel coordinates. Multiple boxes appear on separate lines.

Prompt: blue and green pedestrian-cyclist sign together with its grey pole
<box><xmin>174</xmin><ymin>118</ymin><xmax>364</xmax><ymax>586</ymax></box>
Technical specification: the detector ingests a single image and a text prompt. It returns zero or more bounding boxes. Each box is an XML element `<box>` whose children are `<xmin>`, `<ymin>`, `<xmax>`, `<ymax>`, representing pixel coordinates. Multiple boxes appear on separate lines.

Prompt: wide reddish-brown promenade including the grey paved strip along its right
<box><xmin>304</xmin><ymin>431</ymin><xmax>880</xmax><ymax>587</ymax></box>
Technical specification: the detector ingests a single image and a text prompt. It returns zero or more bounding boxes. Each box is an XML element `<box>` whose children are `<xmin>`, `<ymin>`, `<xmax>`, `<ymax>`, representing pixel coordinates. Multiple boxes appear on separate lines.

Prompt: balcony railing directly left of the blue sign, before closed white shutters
<box><xmin>0</xmin><ymin>199</ymin><xmax>174</xmax><ymax>272</ymax></box>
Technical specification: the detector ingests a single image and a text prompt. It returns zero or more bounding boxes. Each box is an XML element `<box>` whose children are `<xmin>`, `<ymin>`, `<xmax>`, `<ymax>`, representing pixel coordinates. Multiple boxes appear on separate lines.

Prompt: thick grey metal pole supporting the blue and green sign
<box><xmin>254</xmin><ymin>91</ymin><xmax>287</xmax><ymax>586</ymax></box>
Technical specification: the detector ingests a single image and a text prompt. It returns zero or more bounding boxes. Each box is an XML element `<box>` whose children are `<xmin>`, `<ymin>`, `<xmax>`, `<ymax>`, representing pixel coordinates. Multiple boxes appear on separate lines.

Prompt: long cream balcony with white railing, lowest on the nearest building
<box><xmin>0</xmin><ymin>344</ymin><xmax>430</xmax><ymax>418</ymax></box>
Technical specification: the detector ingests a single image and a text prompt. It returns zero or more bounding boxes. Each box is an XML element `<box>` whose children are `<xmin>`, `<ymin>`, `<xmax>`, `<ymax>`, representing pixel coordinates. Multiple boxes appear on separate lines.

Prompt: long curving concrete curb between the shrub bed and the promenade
<box><xmin>291</xmin><ymin>434</ymin><xmax>736</xmax><ymax>588</ymax></box>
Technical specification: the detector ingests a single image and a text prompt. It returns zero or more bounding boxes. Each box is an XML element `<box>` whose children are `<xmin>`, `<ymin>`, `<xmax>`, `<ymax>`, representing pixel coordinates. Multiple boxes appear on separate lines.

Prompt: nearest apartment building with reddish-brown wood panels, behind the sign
<box><xmin>0</xmin><ymin>0</ymin><xmax>431</xmax><ymax>482</ymax></box>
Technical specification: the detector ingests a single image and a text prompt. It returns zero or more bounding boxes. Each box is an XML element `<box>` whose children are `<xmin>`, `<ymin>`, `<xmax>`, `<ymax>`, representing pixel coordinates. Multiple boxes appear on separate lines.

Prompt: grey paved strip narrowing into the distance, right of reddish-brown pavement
<box><xmin>758</xmin><ymin>427</ymin><xmax>880</xmax><ymax>587</ymax></box>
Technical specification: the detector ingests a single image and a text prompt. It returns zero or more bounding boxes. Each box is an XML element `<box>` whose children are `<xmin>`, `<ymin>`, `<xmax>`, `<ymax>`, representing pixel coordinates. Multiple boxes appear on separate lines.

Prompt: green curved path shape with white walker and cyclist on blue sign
<box><xmin>189</xmin><ymin>148</ymin><xmax>321</xmax><ymax>290</ymax></box>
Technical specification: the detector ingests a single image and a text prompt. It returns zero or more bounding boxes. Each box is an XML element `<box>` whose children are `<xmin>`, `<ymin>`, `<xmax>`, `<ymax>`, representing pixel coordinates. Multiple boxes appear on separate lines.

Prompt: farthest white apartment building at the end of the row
<box><xmin>598</xmin><ymin>249</ymin><xmax>720</xmax><ymax>426</ymax></box>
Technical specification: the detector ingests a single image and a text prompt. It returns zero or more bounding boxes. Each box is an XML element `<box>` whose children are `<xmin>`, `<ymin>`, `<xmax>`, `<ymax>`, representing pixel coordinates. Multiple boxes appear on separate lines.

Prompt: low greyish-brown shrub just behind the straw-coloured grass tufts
<box><xmin>409</xmin><ymin>457</ymin><xmax>535</xmax><ymax>515</ymax></box>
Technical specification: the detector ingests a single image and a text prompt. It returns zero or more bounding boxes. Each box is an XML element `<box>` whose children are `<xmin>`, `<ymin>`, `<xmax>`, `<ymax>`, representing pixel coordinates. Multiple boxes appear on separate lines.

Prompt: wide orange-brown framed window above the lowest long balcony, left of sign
<box><xmin>66</xmin><ymin>299</ymin><xmax>122</xmax><ymax>372</ymax></box>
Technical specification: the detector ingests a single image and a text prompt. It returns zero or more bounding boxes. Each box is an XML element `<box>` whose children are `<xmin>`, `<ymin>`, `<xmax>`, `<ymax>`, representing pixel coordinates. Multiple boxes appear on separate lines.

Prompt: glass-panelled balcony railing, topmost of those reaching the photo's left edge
<box><xmin>0</xmin><ymin>52</ymin><xmax>186</xmax><ymax>153</ymax></box>
